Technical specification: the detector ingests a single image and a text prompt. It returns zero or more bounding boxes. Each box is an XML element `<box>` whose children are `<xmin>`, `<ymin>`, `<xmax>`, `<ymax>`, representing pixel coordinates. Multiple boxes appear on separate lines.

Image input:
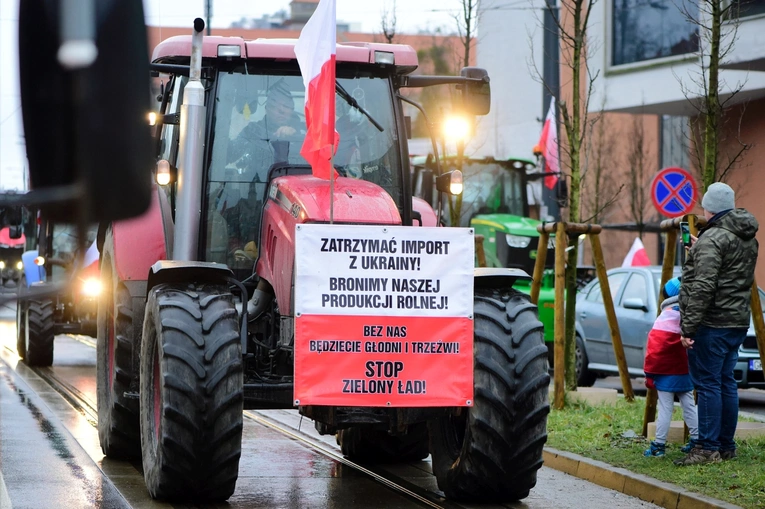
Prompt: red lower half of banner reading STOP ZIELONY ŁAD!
<box><xmin>295</xmin><ymin>315</ymin><xmax>473</xmax><ymax>407</ymax></box>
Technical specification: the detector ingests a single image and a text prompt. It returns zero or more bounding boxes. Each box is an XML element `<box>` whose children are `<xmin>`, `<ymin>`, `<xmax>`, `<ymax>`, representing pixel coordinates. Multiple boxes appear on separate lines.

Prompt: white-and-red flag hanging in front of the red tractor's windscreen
<box><xmin>295</xmin><ymin>0</ymin><xmax>337</xmax><ymax>179</ymax></box>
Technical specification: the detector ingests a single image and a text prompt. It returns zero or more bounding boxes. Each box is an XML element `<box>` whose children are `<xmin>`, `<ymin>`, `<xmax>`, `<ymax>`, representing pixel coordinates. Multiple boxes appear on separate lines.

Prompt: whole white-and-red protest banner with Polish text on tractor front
<box><xmin>294</xmin><ymin>224</ymin><xmax>475</xmax><ymax>407</ymax></box>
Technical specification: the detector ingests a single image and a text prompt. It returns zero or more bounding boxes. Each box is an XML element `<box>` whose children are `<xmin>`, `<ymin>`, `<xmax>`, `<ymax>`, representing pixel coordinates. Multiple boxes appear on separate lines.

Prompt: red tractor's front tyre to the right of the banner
<box><xmin>429</xmin><ymin>289</ymin><xmax>550</xmax><ymax>502</ymax></box>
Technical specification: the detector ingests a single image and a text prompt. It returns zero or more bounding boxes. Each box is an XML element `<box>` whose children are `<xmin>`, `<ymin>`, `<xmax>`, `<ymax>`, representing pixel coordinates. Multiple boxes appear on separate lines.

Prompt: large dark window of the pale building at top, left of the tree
<box><xmin>611</xmin><ymin>0</ymin><xmax>696</xmax><ymax>65</ymax></box>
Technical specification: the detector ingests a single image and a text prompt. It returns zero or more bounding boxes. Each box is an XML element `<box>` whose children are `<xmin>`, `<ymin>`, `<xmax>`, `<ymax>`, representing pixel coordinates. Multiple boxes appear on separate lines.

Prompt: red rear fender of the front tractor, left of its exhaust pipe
<box><xmin>112</xmin><ymin>185</ymin><xmax>173</xmax><ymax>281</ymax></box>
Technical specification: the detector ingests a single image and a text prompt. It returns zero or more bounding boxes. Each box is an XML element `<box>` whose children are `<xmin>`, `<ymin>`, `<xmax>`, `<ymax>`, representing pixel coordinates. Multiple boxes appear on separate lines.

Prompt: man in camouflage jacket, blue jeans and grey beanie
<box><xmin>675</xmin><ymin>182</ymin><xmax>759</xmax><ymax>466</ymax></box>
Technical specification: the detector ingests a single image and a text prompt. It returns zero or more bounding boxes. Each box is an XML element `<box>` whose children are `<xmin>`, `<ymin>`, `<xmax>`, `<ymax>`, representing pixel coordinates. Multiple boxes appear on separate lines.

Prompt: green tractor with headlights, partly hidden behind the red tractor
<box><xmin>412</xmin><ymin>155</ymin><xmax>594</xmax><ymax>371</ymax></box>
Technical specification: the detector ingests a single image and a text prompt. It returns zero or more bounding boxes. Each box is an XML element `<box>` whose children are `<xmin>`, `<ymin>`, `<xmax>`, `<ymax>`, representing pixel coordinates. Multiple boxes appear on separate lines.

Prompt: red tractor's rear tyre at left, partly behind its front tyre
<box><xmin>96</xmin><ymin>241</ymin><xmax>141</xmax><ymax>459</ymax></box>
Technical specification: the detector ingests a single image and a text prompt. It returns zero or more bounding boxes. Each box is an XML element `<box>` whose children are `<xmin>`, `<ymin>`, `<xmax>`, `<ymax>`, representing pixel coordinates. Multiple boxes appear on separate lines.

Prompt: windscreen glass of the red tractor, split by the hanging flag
<box><xmin>205</xmin><ymin>73</ymin><xmax>402</xmax><ymax>269</ymax></box>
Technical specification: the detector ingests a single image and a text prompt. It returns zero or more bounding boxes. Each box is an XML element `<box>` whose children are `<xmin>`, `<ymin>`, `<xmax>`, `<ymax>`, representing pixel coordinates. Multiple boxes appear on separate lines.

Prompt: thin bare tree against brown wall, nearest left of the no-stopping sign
<box><xmin>625</xmin><ymin>115</ymin><xmax>657</xmax><ymax>240</ymax></box>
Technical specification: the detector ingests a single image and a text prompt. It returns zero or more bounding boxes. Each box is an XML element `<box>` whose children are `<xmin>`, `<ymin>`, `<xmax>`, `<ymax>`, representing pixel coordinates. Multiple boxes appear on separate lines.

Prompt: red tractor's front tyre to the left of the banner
<box><xmin>140</xmin><ymin>284</ymin><xmax>244</xmax><ymax>502</ymax></box>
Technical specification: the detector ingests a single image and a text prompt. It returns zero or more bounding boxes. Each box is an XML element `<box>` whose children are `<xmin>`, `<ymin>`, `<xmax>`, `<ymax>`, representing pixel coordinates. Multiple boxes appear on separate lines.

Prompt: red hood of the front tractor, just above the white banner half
<box><xmin>268</xmin><ymin>175</ymin><xmax>401</xmax><ymax>225</ymax></box>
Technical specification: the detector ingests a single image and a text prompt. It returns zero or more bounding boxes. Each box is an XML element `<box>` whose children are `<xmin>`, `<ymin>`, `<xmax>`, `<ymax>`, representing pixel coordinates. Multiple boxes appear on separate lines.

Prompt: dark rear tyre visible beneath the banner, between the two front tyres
<box><xmin>337</xmin><ymin>422</ymin><xmax>430</xmax><ymax>463</ymax></box>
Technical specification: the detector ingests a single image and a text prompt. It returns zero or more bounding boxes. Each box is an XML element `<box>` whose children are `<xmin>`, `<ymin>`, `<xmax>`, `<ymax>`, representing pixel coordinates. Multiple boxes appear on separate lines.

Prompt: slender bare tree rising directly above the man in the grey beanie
<box><xmin>679</xmin><ymin>0</ymin><xmax>752</xmax><ymax>189</ymax></box>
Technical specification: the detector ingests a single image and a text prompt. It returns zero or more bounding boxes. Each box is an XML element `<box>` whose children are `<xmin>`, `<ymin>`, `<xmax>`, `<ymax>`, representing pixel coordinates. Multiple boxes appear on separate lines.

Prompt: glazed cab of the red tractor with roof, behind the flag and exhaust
<box><xmin>155</xmin><ymin>42</ymin><xmax>410</xmax><ymax>279</ymax></box>
